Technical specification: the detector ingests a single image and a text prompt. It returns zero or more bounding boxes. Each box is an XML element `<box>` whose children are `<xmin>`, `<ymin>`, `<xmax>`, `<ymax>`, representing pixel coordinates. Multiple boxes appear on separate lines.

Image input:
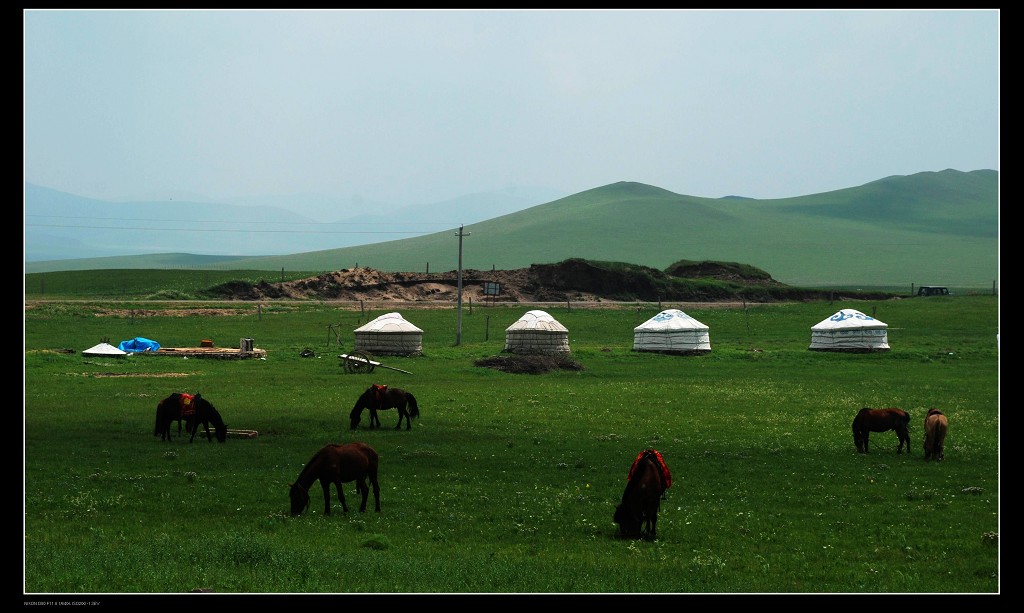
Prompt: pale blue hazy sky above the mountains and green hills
<box><xmin>23</xmin><ymin>9</ymin><xmax>999</xmax><ymax>205</ymax></box>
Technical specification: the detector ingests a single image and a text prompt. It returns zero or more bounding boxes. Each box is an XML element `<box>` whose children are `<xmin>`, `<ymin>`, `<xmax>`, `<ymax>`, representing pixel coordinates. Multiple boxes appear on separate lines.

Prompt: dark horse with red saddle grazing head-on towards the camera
<box><xmin>612</xmin><ymin>449</ymin><xmax>672</xmax><ymax>538</ymax></box>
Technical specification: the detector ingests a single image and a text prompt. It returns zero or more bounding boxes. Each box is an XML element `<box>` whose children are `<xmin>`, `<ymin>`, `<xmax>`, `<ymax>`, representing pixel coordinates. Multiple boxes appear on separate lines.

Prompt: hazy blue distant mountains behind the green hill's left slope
<box><xmin>25</xmin><ymin>183</ymin><xmax>565</xmax><ymax>262</ymax></box>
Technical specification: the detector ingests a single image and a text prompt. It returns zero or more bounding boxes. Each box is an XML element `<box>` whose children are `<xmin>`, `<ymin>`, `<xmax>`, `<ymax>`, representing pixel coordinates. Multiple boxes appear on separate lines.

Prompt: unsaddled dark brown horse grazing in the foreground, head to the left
<box><xmin>289</xmin><ymin>443</ymin><xmax>381</xmax><ymax>517</ymax></box>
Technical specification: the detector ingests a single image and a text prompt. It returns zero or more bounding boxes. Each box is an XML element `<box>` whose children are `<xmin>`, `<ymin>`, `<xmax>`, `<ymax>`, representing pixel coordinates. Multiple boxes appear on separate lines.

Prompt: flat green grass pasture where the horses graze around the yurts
<box><xmin>25</xmin><ymin>296</ymin><xmax>999</xmax><ymax>594</ymax></box>
